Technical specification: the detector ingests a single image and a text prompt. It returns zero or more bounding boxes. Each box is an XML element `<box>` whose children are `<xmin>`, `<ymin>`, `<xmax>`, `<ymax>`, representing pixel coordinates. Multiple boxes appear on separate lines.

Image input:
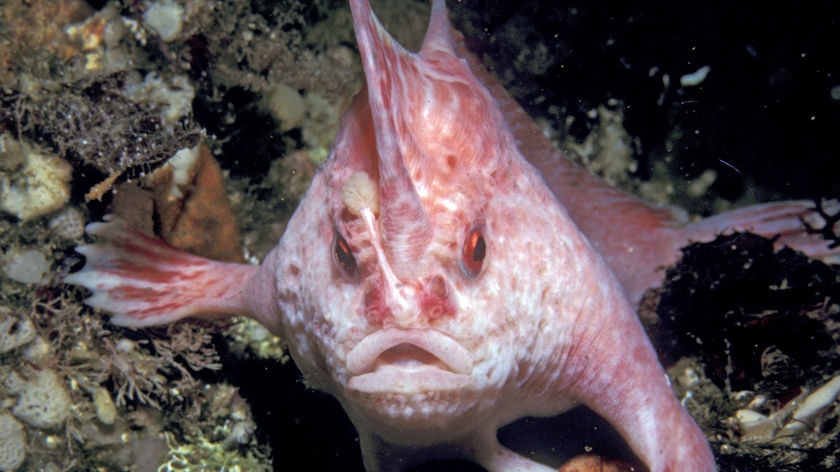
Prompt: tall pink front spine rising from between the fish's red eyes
<box><xmin>350</xmin><ymin>0</ymin><xmax>436</xmax><ymax>280</ymax></box>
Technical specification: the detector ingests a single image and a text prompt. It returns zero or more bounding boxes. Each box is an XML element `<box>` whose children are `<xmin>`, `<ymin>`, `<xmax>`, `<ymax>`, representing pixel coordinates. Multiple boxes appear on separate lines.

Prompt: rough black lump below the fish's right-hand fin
<box><xmin>654</xmin><ymin>233</ymin><xmax>840</xmax><ymax>378</ymax></box>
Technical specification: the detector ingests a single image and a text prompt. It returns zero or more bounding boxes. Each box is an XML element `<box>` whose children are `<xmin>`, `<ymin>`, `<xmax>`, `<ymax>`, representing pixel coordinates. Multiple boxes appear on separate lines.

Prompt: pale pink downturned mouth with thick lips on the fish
<box><xmin>347</xmin><ymin>329</ymin><xmax>473</xmax><ymax>394</ymax></box>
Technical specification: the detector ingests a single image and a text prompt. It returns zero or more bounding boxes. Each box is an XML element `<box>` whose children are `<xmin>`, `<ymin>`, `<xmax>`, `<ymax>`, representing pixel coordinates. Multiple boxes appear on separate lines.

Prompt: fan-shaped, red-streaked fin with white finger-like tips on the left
<box><xmin>64</xmin><ymin>216</ymin><xmax>258</xmax><ymax>327</ymax></box>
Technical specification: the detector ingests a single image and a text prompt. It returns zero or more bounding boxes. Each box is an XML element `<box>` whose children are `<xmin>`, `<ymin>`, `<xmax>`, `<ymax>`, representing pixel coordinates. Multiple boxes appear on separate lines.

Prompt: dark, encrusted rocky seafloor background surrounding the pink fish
<box><xmin>0</xmin><ymin>0</ymin><xmax>840</xmax><ymax>471</ymax></box>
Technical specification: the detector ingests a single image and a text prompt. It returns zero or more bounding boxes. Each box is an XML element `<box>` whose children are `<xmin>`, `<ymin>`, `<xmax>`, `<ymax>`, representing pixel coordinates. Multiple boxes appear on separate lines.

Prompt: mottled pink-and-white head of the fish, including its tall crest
<box><xmin>280</xmin><ymin>1</ymin><xmax>592</xmax><ymax>443</ymax></box>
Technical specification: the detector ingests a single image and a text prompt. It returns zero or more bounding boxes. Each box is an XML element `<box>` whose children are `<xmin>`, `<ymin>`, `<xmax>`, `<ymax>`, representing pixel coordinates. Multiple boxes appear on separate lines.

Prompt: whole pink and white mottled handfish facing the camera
<box><xmin>66</xmin><ymin>0</ymin><xmax>836</xmax><ymax>472</ymax></box>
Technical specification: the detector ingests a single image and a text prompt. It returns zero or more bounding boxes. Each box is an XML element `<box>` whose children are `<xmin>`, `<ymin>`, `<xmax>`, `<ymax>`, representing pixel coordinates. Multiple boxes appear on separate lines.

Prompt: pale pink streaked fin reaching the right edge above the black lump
<box><xmin>685</xmin><ymin>200</ymin><xmax>840</xmax><ymax>264</ymax></box>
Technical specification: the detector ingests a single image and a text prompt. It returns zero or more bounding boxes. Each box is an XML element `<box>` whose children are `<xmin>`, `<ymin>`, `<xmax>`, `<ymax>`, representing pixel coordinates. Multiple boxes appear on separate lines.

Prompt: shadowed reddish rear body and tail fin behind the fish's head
<box><xmin>456</xmin><ymin>37</ymin><xmax>840</xmax><ymax>303</ymax></box>
